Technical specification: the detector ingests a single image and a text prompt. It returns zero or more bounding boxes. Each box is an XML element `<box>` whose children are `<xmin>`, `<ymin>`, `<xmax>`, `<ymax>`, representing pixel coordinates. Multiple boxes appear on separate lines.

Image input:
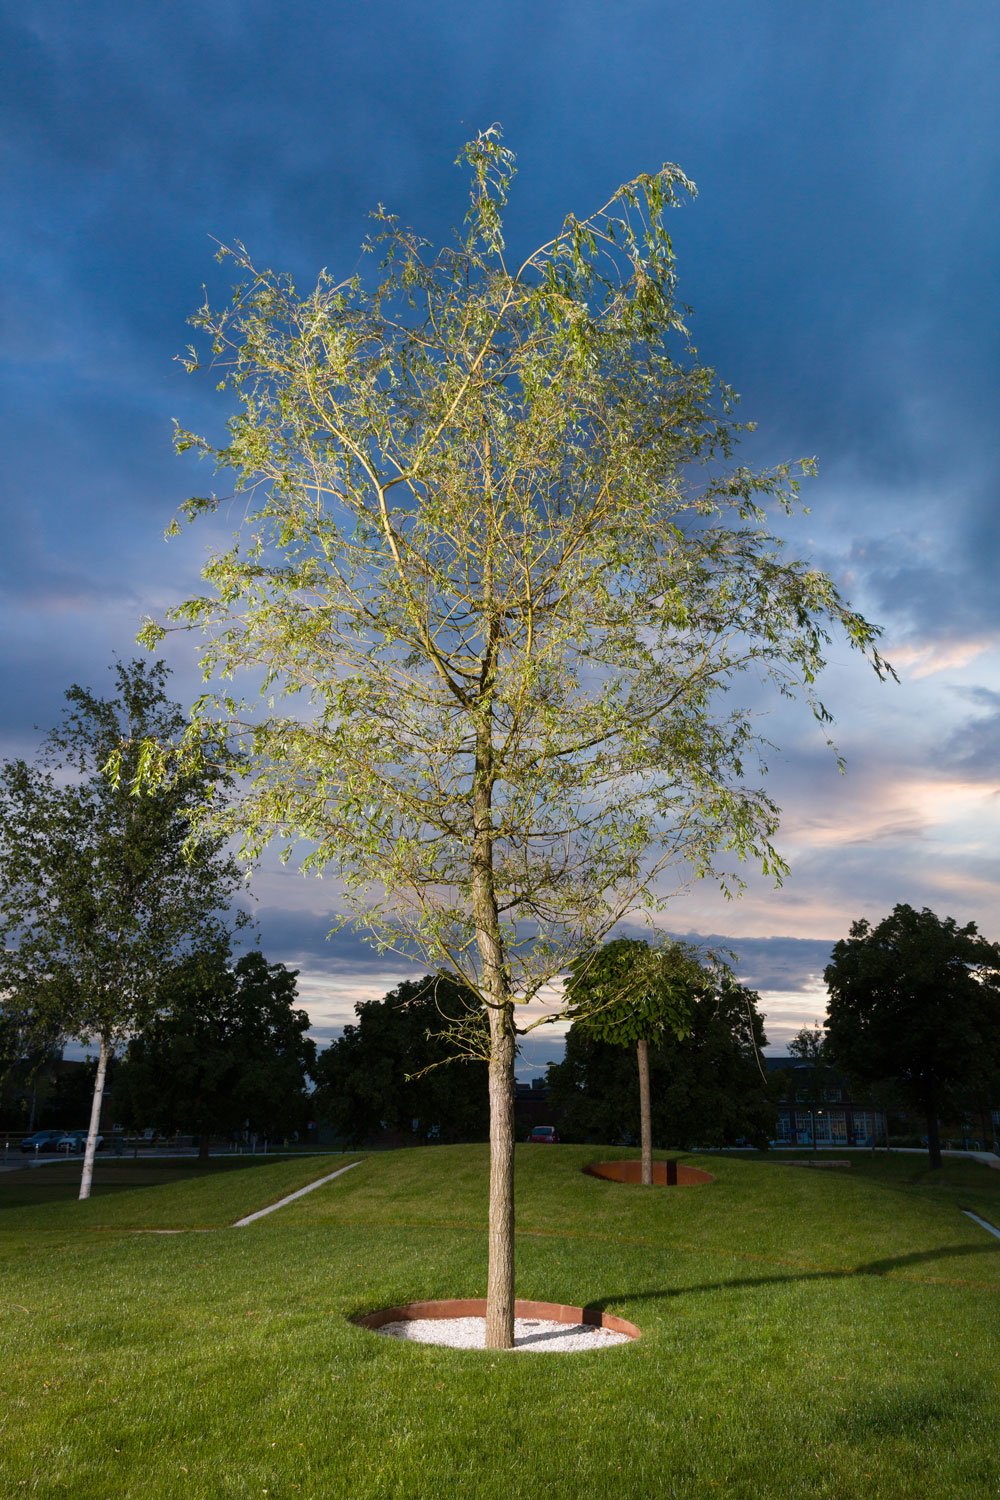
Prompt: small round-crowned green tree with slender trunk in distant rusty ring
<box><xmin>567</xmin><ymin>938</ymin><xmax>711</xmax><ymax>1187</ymax></box>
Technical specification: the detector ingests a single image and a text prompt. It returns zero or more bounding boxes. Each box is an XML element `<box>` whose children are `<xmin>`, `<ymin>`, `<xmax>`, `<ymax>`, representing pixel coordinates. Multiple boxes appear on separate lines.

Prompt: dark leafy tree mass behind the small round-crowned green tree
<box><xmin>549</xmin><ymin>981</ymin><xmax>775</xmax><ymax>1151</ymax></box>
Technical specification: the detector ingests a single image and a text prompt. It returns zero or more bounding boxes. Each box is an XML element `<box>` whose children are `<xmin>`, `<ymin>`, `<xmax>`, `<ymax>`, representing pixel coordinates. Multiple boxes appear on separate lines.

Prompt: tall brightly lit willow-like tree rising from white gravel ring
<box><xmin>137</xmin><ymin>129</ymin><xmax>882</xmax><ymax>1347</ymax></box>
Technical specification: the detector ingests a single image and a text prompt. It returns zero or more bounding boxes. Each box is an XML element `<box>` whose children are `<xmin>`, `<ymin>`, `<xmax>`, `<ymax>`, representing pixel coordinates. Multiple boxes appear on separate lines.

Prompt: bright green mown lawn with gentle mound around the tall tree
<box><xmin>0</xmin><ymin>1146</ymin><xmax>1000</xmax><ymax>1500</ymax></box>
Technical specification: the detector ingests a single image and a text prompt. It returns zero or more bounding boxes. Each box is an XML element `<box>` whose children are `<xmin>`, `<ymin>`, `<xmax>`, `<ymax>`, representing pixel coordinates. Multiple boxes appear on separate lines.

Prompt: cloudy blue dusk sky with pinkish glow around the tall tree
<box><xmin>0</xmin><ymin>0</ymin><xmax>1000</xmax><ymax>1061</ymax></box>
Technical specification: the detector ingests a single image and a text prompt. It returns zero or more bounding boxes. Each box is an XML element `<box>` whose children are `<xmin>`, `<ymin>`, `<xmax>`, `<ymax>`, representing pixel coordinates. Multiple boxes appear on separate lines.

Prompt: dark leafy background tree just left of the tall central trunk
<box><xmin>315</xmin><ymin>974</ymin><xmax>489</xmax><ymax>1143</ymax></box>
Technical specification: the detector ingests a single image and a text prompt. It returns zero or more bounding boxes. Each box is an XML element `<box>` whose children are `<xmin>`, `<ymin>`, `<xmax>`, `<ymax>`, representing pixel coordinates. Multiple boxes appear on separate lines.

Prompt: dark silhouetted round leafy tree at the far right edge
<box><xmin>823</xmin><ymin>905</ymin><xmax>1000</xmax><ymax>1169</ymax></box>
